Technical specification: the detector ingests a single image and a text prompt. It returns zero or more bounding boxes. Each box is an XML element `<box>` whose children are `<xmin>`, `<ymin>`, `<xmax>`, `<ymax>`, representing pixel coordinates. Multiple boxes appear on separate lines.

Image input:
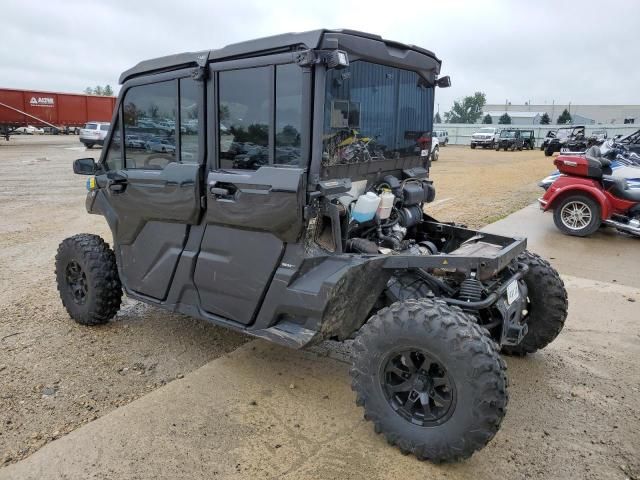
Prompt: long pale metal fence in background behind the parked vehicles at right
<box><xmin>433</xmin><ymin>123</ymin><xmax>640</xmax><ymax>147</ymax></box>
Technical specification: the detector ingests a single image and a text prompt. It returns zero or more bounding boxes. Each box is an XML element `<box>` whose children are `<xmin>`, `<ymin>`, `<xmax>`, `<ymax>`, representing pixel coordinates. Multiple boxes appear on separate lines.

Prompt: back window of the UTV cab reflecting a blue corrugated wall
<box><xmin>322</xmin><ymin>60</ymin><xmax>433</xmax><ymax>167</ymax></box>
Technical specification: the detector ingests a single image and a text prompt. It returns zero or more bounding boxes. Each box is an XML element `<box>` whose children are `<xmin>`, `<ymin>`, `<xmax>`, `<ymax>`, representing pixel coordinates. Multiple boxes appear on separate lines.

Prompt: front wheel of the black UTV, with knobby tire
<box><xmin>56</xmin><ymin>233</ymin><xmax>122</xmax><ymax>325</ymax></box>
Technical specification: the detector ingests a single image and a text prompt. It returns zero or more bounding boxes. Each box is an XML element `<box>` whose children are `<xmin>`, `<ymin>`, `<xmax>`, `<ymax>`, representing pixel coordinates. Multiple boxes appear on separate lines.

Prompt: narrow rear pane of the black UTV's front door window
<box><xmin>180</xmin><ymin>78</ymin><xmax>202</xmax><ymax>163</ymax></box>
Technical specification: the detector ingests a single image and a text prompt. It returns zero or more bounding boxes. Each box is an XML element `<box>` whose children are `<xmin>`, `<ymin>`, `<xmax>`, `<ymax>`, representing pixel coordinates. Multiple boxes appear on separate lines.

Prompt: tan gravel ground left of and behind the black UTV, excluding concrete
<box><xmin>0</xmin><ymin>136</ymin><xmax>568</xmax><ymax>465</ymax></box>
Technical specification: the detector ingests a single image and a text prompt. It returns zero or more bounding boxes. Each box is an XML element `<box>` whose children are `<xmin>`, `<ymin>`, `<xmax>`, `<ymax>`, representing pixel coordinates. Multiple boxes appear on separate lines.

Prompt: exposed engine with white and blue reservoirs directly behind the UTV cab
<box><xmin>313</xmin><ymin>168</ymin><xmax>482</xmax><ymax>256</ymax></box>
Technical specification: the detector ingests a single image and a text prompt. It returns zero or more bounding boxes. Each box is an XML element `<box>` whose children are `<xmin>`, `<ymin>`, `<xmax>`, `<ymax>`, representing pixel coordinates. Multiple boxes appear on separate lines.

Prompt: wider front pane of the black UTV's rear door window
<box><xmin>218</xmin><ymin>67</ymin><xmax>272</xmax><ymax>170</ymax></box>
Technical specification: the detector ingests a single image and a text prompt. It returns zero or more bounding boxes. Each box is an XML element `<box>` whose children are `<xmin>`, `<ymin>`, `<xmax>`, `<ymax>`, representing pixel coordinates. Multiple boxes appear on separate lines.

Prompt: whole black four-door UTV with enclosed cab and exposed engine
<box><xmin>56</xmin><ymin>30</ymin><xmax>567</xmax><ymax>461</ymax></box>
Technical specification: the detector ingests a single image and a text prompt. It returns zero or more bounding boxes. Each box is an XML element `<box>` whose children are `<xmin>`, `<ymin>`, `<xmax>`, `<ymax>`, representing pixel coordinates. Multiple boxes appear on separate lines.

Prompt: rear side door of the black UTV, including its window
<box><xmin>194</xmin><ymin>61</ymin><xmax>309</xmax><ymax>325</ymax></box>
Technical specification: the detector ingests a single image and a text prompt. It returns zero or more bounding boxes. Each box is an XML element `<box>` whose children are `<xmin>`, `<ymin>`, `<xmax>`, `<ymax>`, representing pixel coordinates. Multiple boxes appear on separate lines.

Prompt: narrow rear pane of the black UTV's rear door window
<box><xmin>275</xmin><ymin>64</ymin><xmax>302</xmax><ymax>166</ymax></box>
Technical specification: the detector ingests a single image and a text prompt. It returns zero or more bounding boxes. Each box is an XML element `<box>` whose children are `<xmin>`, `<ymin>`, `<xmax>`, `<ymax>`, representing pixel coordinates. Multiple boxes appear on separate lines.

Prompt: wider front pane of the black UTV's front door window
<box><xmin>123</xmin><ymin>80</ymin><xmax>178</xmax><ymax>170</ymax></box>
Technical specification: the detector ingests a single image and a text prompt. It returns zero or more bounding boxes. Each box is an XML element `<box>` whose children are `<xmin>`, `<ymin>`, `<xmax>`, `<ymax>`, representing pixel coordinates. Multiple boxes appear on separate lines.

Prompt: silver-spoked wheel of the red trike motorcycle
<box><xmin>553</xmin><ymin>194</ymin><xmax>602</xmax><ymax>237</ymax></box>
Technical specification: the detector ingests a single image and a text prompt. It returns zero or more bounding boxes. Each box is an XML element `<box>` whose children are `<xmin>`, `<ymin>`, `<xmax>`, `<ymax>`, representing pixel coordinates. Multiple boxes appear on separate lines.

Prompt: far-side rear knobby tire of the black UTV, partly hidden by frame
<box><xmin>502</xmin><ymin>252</ymin><xmax>569</xmax><ymax>355</ymax></box>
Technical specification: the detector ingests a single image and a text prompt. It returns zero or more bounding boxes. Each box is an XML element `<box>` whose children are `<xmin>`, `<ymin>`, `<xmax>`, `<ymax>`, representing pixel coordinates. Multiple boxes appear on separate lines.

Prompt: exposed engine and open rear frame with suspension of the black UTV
<box><xmin>310</xmin><ymin>168</ymin><xmax>527</xmax><ymax>344</ymax></box>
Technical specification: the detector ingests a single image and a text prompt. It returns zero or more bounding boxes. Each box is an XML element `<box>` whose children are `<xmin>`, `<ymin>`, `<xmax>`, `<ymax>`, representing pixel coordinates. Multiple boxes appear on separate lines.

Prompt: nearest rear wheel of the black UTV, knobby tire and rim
<box><xmin>351</xmin><ymin>299</ymin><xmax>508</xmax><ymax>463</ymax></box>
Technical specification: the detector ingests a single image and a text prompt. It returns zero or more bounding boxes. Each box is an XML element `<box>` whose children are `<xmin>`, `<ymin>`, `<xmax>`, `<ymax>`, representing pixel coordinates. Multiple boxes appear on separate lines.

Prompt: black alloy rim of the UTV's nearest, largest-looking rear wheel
<box><xmin>380</xmin><ymin>349</ymin><xmax>456</xmax><ymax>427</ymax></box>
